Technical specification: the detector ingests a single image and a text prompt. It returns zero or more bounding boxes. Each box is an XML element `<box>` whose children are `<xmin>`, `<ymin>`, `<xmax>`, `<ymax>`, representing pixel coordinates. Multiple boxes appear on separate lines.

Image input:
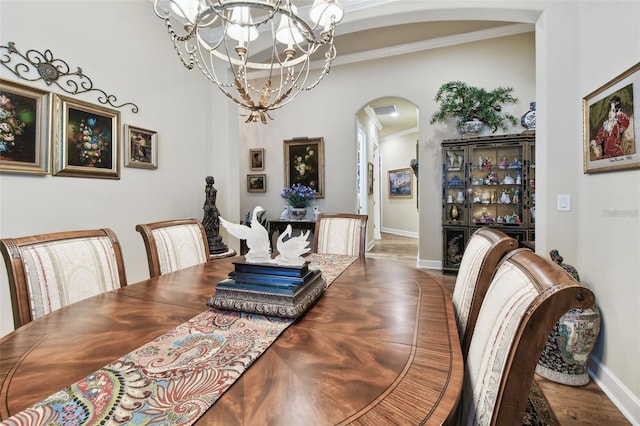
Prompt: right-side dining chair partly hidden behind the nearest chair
<box><xmin>451</xmin><ymin>227</ymin><xmax>518</xmax><ymax>358</ymax></box>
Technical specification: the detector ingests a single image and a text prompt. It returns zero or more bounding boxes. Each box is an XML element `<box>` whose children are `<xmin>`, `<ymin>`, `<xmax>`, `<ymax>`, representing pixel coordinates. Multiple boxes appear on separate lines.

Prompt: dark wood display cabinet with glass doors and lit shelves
<box><xmin>442</xmin><ymin>133</ymin><xmax>535</xmax><ymax>273</ymax></box>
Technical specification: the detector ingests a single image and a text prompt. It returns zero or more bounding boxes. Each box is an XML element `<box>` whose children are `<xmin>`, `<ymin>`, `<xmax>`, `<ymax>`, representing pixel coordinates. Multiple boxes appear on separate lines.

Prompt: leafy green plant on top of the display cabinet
<box><xmin>431</xmin><ymin>81</ymin><xmax>518</xmax><ymax>134</ymax></box>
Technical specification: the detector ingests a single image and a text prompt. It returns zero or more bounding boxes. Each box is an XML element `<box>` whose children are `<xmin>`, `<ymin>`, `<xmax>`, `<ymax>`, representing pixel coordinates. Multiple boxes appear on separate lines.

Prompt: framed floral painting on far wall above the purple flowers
<box><xmin>284</xmin><ymin>138</ymin><xmax>324</xmax><ymax>198</ymax></box>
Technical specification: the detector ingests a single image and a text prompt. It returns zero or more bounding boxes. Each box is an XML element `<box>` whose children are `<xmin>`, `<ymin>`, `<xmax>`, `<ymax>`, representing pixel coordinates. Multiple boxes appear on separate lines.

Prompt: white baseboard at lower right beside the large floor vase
<box><xmin>589</xmin><ymin>355</ymin><xmax>640</xmax><ymax>426</ymax></box>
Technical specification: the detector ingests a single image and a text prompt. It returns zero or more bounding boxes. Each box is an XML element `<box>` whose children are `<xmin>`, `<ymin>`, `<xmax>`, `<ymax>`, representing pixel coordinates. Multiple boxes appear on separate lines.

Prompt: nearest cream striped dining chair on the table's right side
<box><xmin>458</xmin><ymin>248</ymin><xmax>595</xmax><ymax>425</ymax></box>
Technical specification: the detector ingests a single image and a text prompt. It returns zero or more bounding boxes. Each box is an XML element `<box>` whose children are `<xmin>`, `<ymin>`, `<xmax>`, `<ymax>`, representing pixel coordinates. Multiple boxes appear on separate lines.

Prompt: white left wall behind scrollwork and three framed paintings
<box><xmin>0</xmin><ymin>0</ymin><xmax>238</xmax><ymax>335</ymax></box>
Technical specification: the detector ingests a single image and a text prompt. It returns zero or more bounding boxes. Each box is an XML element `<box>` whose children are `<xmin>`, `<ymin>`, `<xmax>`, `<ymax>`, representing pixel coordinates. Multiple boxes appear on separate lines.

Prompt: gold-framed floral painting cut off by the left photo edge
<box><xmin>0</xmin><ymin>79</ymin><xmax>51</xmax><ymax>175</ymax></box>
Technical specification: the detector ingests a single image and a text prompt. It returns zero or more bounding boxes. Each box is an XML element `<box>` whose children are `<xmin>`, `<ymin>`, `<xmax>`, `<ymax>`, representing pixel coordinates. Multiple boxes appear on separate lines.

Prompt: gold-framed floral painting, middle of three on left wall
<box><xmin>52</xmin><ymin>95</ymin><xmax>120</xmax><ymax>179</ymax></box>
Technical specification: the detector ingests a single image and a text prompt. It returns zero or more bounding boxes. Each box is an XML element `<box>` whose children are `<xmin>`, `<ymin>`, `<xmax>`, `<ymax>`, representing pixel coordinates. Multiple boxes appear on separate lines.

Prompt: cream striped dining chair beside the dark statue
<box><xmin>136</xmin><ymin>219</ymin><xmax>209</xmax><ymax>278</ymax></box>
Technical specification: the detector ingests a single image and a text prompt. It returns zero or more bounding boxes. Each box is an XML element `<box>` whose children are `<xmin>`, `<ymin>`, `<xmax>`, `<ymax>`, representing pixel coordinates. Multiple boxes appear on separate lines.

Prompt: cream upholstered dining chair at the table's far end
<box><xmin>313</xmin><ymin>213</ymin><xmax>369</xmax><ymax>256</ymax></box>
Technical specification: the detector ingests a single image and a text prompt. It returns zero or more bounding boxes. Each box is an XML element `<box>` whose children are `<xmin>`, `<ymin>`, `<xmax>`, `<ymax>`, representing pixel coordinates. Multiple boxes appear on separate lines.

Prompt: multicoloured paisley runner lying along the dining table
<box><xmin>1</xmin><ymin>254</ymin><xmax>357</xmax><ymax>425</ymax></box>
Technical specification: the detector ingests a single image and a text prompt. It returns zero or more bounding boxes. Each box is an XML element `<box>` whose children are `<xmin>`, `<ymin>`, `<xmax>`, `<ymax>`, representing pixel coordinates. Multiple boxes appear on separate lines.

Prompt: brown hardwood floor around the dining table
<box><xmin>366</xmin><ymin>233</ymin><xmax>631</xmax><ymax>426</ymax></box>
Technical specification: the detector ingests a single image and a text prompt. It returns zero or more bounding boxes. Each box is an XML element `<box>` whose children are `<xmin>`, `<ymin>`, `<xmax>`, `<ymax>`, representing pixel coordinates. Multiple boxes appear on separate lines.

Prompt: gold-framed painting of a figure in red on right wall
<box><xmin>583</xmin><ymin>63</ymin><xmax>640</xmax><ymax>173</ymax></box>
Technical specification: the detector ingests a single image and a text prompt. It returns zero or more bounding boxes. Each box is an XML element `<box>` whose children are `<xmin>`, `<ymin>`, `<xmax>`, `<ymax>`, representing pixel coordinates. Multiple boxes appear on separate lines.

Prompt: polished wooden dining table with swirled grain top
<box><xmin>0</xmin><ymin>257</ymin><xmax>464</xmax><ymax>425</ymax></box>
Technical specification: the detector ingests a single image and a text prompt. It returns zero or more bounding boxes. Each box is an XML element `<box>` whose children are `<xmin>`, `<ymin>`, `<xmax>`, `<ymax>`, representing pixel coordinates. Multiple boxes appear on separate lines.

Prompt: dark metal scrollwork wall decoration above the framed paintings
<box><xmin>0</xmin><ymin>42</ymin><xmax>138</xmax><ymax>113</ymax></box>
